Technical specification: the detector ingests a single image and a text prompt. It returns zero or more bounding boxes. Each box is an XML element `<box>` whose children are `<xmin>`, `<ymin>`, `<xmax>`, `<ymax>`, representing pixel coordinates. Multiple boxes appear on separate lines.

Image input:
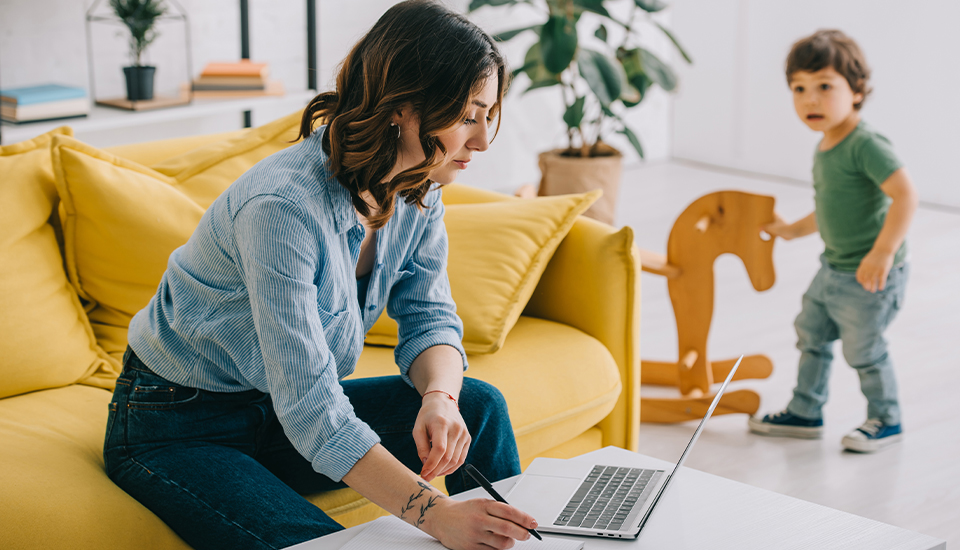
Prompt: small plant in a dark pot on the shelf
<box><xmin>110</xmin><ymin>0</ymin><xmax>167</xmax><ymax>101</ymax></box>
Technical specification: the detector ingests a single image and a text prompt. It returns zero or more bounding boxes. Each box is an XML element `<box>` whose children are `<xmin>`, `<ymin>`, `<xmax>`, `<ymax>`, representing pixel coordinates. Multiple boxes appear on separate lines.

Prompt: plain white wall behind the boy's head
<box><xmin>672</xmin><ymin>0</ymin><xmax>960</xmax><ymax>206</ymax></box>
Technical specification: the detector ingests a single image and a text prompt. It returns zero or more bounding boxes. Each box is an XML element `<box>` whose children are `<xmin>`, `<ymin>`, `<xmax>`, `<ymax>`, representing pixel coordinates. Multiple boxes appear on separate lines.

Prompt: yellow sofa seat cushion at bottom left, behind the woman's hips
<box><xmin>0</xmin><ymin>385</ymin><xmax>189</xmax><ymax>549</ymax></box>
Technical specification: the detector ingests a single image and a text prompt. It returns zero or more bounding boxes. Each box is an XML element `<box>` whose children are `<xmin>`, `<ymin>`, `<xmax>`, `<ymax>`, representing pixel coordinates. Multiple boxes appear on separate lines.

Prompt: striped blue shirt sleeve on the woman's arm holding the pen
<box><xmin>234</xmin><ymin>195</ymin><xmax>380</xmax><ymax>481</ymax></box>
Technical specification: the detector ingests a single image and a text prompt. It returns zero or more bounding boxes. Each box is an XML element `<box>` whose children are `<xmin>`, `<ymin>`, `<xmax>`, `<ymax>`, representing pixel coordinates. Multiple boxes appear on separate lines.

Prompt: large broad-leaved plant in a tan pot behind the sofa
<box><xmin>469</xmin><ymin>0</ymin><xmax>692</xmax><ymax>223</ymax></box>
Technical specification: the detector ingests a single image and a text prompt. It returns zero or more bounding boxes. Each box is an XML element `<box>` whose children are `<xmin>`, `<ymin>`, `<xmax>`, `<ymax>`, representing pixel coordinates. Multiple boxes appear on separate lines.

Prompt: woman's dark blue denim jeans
<box><xmin>103</xmin><ymin>348</ymin><xmax>520</xmax><ymax>549</ymax></box>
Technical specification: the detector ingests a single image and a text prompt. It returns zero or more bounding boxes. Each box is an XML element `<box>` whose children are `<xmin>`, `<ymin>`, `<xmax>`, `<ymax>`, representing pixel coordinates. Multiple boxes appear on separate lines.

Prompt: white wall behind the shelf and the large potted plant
<box><xmin>0</xmin><ymin>0</ymin><xmax>670</xmax><ymax>191</ymax></box>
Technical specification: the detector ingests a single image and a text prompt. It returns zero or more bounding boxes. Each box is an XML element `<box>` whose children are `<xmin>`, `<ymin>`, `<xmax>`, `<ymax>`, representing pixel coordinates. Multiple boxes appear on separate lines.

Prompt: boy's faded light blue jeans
<box><xmin>787</xmin><ymin>257</ymin><xmax>909</xmax><ymax>425</ymax></box>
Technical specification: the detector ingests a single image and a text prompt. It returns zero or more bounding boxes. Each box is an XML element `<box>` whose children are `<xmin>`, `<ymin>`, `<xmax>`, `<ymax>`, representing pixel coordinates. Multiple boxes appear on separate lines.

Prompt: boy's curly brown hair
<box><xmin>786</xmin><ymin>29</ymin><xmax>873</xmax><ymax>110</ymax></box>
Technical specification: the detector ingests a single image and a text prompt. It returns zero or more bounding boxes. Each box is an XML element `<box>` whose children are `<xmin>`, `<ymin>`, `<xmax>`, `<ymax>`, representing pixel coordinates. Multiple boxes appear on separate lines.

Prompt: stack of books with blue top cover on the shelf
<box><xmin>0</xmin><ymin>84</ymin><xmax>90</xmax><ymax>124</ymax></box>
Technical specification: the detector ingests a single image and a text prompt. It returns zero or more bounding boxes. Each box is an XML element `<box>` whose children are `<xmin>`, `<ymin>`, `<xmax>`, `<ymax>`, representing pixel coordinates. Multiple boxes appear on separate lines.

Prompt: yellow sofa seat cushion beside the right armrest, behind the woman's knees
<box><xmin>352</xmin><ymin>316</ymin><xmax>621</xmax><ymax>460</ymax></box>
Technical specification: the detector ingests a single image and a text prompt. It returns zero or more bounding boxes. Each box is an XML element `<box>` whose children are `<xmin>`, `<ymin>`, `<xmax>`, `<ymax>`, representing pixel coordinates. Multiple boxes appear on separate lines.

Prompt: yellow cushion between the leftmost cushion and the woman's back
<box><xmin>53</xmin><ymin>137</ymin><xmax>203</xmax><ymax>357</ymax></box>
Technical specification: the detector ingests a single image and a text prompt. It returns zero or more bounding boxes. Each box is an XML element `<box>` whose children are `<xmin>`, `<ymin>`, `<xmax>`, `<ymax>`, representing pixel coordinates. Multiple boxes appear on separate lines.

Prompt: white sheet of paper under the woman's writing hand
<box><xmin>341</xmin><ymin>516</ymin><xmax>583</xmax><ymax>550</ymax></box>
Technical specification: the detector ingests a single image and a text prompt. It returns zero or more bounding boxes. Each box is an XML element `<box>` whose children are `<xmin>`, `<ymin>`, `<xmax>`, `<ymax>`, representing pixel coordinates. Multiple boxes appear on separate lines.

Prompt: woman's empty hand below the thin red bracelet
<box><xmin>413</xmin><ymin>392</ymin><xmax>470</xmax><ymax>481</ymax></box>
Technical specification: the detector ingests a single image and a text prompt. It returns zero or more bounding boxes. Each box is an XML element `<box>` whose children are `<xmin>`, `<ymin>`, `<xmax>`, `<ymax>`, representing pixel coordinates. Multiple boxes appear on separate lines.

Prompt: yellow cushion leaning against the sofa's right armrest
<box><xmin>366</xmin><ymin>191</ymin><xmax>600</xmax><ymax>354</ymax></box>
